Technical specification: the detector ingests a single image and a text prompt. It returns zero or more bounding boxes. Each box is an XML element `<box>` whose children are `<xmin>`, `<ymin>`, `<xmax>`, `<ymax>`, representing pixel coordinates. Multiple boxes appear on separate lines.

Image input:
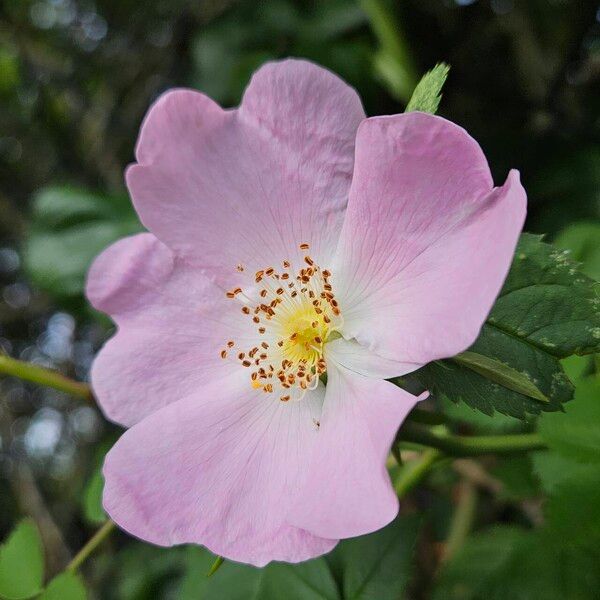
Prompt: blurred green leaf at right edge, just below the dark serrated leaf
<box><xmin>539</xmin><ymin>377</ymin><xmax>600</xmax><ymax>462</ymax></box>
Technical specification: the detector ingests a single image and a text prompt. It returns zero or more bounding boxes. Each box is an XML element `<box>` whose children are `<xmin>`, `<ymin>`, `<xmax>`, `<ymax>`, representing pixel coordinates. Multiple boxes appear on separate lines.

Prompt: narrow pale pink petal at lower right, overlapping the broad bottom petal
<box><xmin>289</xmin><ymin>362</ymin><xmax>420</xmax><ymax>538</ymax></box>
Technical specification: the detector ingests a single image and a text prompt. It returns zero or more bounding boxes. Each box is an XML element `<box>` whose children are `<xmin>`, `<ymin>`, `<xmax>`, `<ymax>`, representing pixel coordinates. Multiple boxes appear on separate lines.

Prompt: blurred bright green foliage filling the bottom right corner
<box><xmin>434</xmin><ymin>376</ymin><xmax>600</xmax><ymax>600</ymax></box>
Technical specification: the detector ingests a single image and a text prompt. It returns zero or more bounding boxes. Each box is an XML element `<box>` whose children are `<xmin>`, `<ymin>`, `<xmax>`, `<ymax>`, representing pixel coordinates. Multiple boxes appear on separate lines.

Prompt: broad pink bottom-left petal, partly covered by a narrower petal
<box><xmin>104</xmin><ymin>375</ymin><xmax>336</xmax><ymax>566</ymax></box>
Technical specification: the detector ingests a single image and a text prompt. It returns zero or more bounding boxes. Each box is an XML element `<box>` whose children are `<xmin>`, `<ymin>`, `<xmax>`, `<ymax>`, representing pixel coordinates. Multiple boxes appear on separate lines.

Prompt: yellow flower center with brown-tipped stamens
<box><xmin>221</xmin><ymin>244</ymin><xmax>342</xmax><ymax>402</ymax></box>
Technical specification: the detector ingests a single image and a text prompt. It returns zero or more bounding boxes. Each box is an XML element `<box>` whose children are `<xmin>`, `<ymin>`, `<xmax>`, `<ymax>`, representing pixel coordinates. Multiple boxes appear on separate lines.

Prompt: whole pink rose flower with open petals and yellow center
<box><xmin>87</xmin><ymin>60</ymin><xmax>526</xmax><ymax>566</ymax></box>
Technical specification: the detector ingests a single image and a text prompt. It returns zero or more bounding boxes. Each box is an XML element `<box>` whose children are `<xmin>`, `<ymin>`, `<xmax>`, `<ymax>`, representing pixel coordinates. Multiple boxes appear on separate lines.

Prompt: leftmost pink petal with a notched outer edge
<box><xmin>87</xmin><ymin>233</ymin><xmax>254</xmax><ymax>426</ymax></box>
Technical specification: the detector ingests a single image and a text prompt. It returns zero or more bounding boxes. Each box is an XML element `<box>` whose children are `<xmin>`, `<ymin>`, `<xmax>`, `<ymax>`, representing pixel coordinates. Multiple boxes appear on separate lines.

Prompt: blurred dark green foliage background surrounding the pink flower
<box><xmin>0</xmin><ymin>0</ymin><xmax>600</xmax><ymax>600</ymax></box>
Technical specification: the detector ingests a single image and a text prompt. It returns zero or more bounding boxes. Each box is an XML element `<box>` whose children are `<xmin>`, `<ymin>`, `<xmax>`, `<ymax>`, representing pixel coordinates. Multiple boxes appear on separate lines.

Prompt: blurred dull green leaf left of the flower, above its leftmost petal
<box><xmin>25</xmin><ymin>187</ymin><xmax>141</xmax><ymax>299</ymax></box>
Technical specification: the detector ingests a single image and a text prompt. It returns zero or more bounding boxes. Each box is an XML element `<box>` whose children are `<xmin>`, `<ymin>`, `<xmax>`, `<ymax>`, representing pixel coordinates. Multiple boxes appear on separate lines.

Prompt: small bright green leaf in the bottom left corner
<box><xmin>0</xmin><ymin>519</ymin><xmax>44</xmax><ymax>600</ymax></box>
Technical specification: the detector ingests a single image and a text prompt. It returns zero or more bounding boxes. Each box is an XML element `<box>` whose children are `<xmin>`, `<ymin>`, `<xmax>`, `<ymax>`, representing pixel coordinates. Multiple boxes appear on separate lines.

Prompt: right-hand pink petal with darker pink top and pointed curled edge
<box><xmin>333</xmin><ymin>113</ymin><xmax>526</xmax><ymax>366</ymax></box>
